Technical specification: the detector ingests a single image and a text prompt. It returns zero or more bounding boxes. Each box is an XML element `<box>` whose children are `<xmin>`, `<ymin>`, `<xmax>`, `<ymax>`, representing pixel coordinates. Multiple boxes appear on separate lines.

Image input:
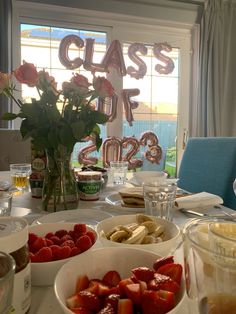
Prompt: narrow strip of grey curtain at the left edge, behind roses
<box><xmin>0</xmin><ymin>0</ymin><xmax>12</xmax><ymax>128</ymax></box>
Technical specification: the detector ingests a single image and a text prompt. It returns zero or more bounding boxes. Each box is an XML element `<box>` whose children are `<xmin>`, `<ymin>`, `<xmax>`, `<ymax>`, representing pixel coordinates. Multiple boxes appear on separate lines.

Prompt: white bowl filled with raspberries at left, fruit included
<box><xmin>28</xmin><ymin>222</ymin><xmax>98</xmax><ymax>286</ymax></box>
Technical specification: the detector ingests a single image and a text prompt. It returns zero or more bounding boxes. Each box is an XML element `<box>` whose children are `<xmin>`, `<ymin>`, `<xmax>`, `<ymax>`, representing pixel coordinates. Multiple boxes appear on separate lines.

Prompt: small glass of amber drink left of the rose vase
<box><xmin>10</xmin><ymin>163</ymin><xmax>31</xmax><ymax>191</ymax></box>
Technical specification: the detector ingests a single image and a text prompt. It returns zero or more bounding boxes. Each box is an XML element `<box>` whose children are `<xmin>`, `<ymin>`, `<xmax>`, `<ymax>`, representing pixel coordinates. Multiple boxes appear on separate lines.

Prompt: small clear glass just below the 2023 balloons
<box><xmin>110</xmin><ymin>161</ymin><xmax>128</xmax><ymax>185</ymax></box>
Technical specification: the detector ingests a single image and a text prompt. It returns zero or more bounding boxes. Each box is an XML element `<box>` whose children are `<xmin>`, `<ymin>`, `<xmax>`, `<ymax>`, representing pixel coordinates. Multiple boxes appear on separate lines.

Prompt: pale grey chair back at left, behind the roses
<box><xmin>0</xmin><ymin>129</ymin><xmax>31</xmax><ymax>171</ymax></box>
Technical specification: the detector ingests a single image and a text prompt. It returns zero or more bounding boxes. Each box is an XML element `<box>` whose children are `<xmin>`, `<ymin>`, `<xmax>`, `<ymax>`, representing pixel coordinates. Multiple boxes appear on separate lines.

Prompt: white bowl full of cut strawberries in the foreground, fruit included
<box><xmin>54</xmin><ymin>247</ymin><xmax>184</xmax><ymax>314</ymax></box>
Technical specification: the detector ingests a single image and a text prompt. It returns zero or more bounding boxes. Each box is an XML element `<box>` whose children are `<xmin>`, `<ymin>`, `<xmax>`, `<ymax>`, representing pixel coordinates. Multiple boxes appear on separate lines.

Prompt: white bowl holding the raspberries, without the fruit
<box><xmin>28</xmin><ymin>222</ymin><xmax>98</xmax><ymax>286</ymax></box>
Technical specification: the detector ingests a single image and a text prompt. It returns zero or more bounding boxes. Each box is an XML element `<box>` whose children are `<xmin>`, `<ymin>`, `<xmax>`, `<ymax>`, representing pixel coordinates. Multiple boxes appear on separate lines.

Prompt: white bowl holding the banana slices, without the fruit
<box><xmin>96</xmin><ymin>215</ymin><xmax>180</xmax><ymax>256</ymax></box>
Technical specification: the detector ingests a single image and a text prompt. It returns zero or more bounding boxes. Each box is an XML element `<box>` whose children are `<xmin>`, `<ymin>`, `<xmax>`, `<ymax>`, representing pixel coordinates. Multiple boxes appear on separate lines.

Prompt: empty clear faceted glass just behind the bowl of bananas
<box><xmin>143</xmin><ymin>180</ymin><xmax>177</xmax><ymax>220</ymax></box>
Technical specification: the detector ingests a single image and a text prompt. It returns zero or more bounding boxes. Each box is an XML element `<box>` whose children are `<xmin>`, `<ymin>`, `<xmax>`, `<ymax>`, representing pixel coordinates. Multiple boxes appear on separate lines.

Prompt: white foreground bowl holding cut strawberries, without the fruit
<box><xmin>54</xmin><ymin>247</ymin><xmax>184</xmax><ymax>314</ymax></box>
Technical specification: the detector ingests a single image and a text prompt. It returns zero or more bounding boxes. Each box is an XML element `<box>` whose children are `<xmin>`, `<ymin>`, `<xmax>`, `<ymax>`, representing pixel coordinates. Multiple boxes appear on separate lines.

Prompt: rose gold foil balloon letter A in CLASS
<box><xmin>102</xmin><ymin>40</ymin><xmax>126</xmax><ymax>76</ymax></box>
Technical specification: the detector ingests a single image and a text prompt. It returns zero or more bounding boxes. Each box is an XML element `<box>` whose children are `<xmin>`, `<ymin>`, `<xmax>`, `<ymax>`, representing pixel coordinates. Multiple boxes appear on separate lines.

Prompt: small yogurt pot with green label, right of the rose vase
<box><xmin>76</xmin><ymin>171</ymin><xmax>103</xmax><ymax>201</ymax></box>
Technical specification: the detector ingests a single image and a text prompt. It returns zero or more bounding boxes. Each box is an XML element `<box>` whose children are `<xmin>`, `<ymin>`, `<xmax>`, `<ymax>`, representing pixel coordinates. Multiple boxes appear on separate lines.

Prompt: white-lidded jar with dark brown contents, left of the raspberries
<box><xmin>0</xmin><ymin>217</ymin><xmax>31</xmax><ymax>314</ymax></box>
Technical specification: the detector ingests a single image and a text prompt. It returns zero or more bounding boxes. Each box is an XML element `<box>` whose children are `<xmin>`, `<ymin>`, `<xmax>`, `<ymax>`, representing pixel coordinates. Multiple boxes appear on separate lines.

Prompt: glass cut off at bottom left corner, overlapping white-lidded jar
<box><xmin>0</xmin><ymin>252</ymin><xmax>15</xmax><ymax>314</ymax></box>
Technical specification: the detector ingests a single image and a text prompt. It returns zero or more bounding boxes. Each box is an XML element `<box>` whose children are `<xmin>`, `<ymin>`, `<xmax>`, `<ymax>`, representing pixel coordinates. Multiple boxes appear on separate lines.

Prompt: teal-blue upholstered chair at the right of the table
<box><xmin>178</xmin><ymin>137</ymin><xmax>236</xmax><ymax>210</ymax></box>
